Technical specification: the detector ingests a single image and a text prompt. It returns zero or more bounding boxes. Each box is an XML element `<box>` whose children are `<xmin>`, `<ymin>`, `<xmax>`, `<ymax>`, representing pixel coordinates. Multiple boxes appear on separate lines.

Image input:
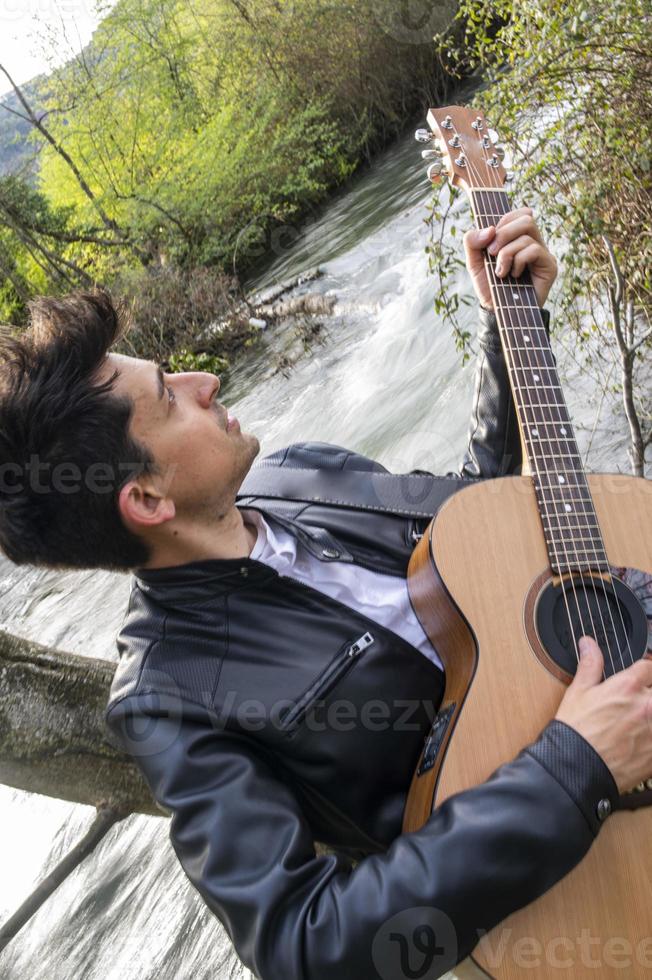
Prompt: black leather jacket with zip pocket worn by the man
<box><xmin>107</xmin><ymin>314</ymin><xmax>617</xmax><ymax>980</ymax></box>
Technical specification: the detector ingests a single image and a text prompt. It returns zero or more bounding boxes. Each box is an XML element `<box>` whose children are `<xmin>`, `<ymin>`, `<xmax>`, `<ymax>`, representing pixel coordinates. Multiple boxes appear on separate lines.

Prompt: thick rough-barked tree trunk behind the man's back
<box><xmin>0</xmin><ymin>631</ymin><xmax>163</xmax><ymax>816</ymax></box>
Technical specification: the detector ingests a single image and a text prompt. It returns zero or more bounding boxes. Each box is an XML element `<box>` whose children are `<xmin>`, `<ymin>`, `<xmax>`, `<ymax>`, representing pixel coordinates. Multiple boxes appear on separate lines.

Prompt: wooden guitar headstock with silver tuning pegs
<box><xmin>415</xmin><ymin>105</ymin><xmax>511</xmax><ymax>192</ymax></box>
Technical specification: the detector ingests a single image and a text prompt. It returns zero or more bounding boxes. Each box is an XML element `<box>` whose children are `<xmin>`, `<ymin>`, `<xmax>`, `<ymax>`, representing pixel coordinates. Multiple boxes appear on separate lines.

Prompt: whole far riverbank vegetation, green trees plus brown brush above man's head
<box><xmin>0</xmin><ymin>0</ymin><xmax>454</xmax><ymax>363</ymax></box>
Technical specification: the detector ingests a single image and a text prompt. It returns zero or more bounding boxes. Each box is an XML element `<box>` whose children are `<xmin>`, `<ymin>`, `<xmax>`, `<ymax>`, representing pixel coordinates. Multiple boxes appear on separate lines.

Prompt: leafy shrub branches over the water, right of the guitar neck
<box><xmin>430</xmin><ymin>0</ymin><xmax>652</xmax><ymax>464</ymax></box>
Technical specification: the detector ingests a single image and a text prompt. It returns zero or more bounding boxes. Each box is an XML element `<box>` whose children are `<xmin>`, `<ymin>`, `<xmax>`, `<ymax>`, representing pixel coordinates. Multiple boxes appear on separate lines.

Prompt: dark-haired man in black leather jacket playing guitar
<box><xmin>0</xmin><ymin>209</ymin><xmax>652</xmax><ymax>980</ymax></box>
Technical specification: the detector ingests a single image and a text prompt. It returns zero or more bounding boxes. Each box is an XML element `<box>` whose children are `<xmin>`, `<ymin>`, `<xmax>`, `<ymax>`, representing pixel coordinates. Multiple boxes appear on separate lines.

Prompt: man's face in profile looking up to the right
<box><xmin>100</xmin><ymin>354</ymin><xmax>260</xmax><ymax>519</ymax></box>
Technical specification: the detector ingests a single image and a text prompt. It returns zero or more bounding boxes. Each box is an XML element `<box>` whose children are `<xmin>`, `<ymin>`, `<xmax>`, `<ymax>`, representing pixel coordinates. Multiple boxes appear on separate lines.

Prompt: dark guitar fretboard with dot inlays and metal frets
<box><xmin>470</xmin><ymin>189</ymin><xmax>609</xmax><ymax>573</ymax></box>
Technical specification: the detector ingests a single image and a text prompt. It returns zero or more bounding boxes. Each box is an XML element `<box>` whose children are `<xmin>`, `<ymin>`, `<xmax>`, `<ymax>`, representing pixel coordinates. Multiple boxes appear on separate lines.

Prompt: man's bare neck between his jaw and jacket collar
<box><xmin>143</xmin><ymin>505</ymin><xmax>257</xmax><ymax>568</ymax></box>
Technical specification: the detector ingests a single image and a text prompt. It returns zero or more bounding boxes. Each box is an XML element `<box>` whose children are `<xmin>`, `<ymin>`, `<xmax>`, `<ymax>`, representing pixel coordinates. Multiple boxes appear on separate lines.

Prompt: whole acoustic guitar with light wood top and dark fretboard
<box><xmin>403</xmin><ymin>106</ymin><xmax>652</xmax><ymax>980</ymax></box>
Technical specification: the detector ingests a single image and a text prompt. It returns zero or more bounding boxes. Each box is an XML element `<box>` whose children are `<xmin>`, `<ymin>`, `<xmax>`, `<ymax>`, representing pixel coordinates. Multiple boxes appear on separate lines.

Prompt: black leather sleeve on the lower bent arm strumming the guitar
<box><xmin>107</xmin><ymin>694</ymin><xmax>617</xmax><ymax>980</ymax></box>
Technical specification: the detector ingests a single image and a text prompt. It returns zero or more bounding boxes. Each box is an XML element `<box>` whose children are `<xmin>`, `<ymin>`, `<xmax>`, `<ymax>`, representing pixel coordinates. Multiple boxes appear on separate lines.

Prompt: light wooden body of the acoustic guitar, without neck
<box><xmin>404</xmin><ymin>475</ymin><xmax>652</xmax><ymax>980</ymax></box>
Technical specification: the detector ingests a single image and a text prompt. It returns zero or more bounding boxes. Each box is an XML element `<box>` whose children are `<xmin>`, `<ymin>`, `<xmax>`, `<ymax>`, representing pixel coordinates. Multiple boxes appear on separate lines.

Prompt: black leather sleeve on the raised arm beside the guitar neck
<box><xmin>460</xmin><ymin>307</ymin><xmax>550</xmax><ymax>478</ymax></box>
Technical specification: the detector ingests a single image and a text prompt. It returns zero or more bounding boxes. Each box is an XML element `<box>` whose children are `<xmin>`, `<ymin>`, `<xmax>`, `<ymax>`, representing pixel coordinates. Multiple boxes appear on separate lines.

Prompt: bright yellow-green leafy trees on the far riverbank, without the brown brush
<box><xmin>30</xmin><ymin>0</ymin><xmax>450</xmax><ymax>275</ymax></box>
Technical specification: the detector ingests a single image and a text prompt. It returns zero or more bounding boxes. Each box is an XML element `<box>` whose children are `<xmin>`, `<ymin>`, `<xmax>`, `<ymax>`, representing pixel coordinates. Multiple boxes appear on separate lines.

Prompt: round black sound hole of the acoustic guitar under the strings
<box><xmin>535</xmin><ymin>568</ymin><xmax>652</xmax><ymax>677</ymax></box>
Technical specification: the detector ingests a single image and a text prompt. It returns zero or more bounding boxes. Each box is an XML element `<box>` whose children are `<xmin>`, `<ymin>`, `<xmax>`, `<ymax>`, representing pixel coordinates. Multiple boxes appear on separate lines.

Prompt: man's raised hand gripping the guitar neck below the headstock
<box><xmin>464</xmin><ymin>208</ymin><xmax>557</xmax><ymax>309</ymax></box>
